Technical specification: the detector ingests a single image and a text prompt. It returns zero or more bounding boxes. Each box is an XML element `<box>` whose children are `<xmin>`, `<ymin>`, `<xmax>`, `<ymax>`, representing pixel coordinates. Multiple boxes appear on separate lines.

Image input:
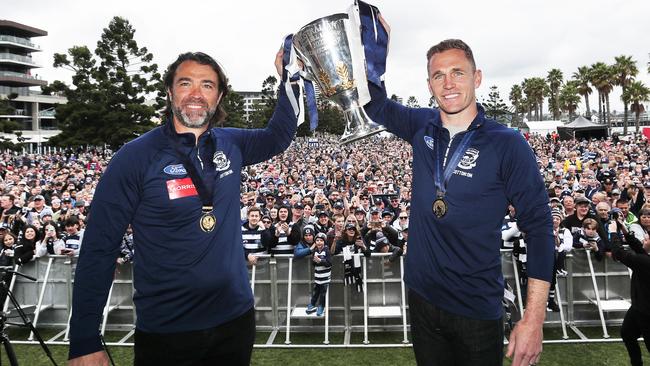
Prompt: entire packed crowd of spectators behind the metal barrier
<box><xmin>0</xmin><ymin>135</ymin><xmax>650</xmax><ymax>298</ymax></box>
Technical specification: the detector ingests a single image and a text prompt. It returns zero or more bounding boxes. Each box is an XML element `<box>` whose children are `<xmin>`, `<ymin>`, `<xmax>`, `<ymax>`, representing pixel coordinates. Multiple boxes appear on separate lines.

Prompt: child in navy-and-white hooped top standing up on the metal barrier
<box><xmin>307</xmin><ymin>233</ymin><xmax>332</xmax><ymax>316</ymax></box>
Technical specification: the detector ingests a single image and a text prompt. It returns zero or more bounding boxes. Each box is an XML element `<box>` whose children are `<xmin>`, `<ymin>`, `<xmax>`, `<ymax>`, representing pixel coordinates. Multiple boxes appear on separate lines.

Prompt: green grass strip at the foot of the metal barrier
<box><xmin>1</xmin><ymin>328</ymin><xmax>650</xmax><ymax>366</ymax></box>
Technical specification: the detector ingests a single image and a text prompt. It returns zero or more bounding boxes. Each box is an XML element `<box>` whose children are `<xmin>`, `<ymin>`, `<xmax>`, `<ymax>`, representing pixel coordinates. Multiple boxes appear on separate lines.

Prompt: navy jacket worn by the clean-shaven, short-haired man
<box><xmin>365</xmin><ymin>84</ymin><xmax>554</xmax><ymax>319</ymax></box>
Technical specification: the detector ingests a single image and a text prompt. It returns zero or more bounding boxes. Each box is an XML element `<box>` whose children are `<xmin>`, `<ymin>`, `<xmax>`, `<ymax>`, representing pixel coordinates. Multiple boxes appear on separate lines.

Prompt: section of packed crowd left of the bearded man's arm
<box><xmin>0</xmin><ymin>151</ymin><xmax>109</xmax><ymax>266</ymax></box>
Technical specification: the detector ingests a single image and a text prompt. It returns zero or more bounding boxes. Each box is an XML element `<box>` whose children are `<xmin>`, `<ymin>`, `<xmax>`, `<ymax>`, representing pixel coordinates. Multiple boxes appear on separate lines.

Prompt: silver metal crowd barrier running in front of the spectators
<box><xmin>4</xmin><ymin>250</ymin><xmax>630</xmax><ymax>348</ymax></box>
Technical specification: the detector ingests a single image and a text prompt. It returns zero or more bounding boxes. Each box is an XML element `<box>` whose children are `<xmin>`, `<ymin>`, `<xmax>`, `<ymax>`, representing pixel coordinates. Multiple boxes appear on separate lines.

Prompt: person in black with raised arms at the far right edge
<box><xmin>609</xmin><ymin>217</ymin><xmax>650</xmax><ymax>366</ymax></box>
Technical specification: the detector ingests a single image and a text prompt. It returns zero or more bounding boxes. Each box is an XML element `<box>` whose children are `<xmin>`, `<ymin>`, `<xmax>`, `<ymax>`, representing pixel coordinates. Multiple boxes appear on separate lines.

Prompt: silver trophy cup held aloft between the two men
<box><xmin>293</xmin><ymin>13</ymin><xmax>385</xmax><ymax>144</ymax></box>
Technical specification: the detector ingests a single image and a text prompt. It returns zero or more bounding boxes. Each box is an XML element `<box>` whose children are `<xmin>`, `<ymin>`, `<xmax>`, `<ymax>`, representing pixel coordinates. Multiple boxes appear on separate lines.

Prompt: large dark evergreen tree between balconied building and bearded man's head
<box><xmin>45</xmin><ymin>17</ymin><xmax>164</xmax><ymax>147</ymax></box>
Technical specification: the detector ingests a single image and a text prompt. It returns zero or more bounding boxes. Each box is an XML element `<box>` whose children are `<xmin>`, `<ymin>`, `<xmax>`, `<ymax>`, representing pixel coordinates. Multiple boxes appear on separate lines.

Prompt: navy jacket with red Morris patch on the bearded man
<box><xmin>69</xmin><ymin>88</ymin><xmax>296</xmax><ymax>358</ymax></box>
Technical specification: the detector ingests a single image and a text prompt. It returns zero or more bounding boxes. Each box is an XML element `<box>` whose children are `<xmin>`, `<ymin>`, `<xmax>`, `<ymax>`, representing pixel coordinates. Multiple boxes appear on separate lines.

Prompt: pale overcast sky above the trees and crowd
<box><xmin>5</xmin><ymin>0</ymin><xmax>650</xmax><ymax>115</ymax></box>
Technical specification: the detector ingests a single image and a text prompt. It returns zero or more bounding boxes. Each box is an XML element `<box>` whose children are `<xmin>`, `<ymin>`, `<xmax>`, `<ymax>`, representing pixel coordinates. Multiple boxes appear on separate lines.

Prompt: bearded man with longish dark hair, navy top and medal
<box><xmin>69</xmin><ymin>52</ymin><xmax>297</xmax><ymax>366</ymax></box>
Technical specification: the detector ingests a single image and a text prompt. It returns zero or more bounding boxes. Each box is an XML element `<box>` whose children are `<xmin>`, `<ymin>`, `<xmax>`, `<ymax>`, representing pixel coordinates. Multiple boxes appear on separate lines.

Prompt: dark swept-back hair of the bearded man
<box><xmin>163</xmin><ymin>52</ymin><xmax>228</xmax><ymax>124</ymax></box>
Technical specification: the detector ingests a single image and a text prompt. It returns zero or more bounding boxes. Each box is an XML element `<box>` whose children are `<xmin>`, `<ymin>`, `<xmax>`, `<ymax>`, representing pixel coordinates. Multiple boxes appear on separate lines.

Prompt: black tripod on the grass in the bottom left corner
<box><xmin>0</xmin><ymin>270</ymin><xmax>57</xmax><ymax>366</ymax></box>
